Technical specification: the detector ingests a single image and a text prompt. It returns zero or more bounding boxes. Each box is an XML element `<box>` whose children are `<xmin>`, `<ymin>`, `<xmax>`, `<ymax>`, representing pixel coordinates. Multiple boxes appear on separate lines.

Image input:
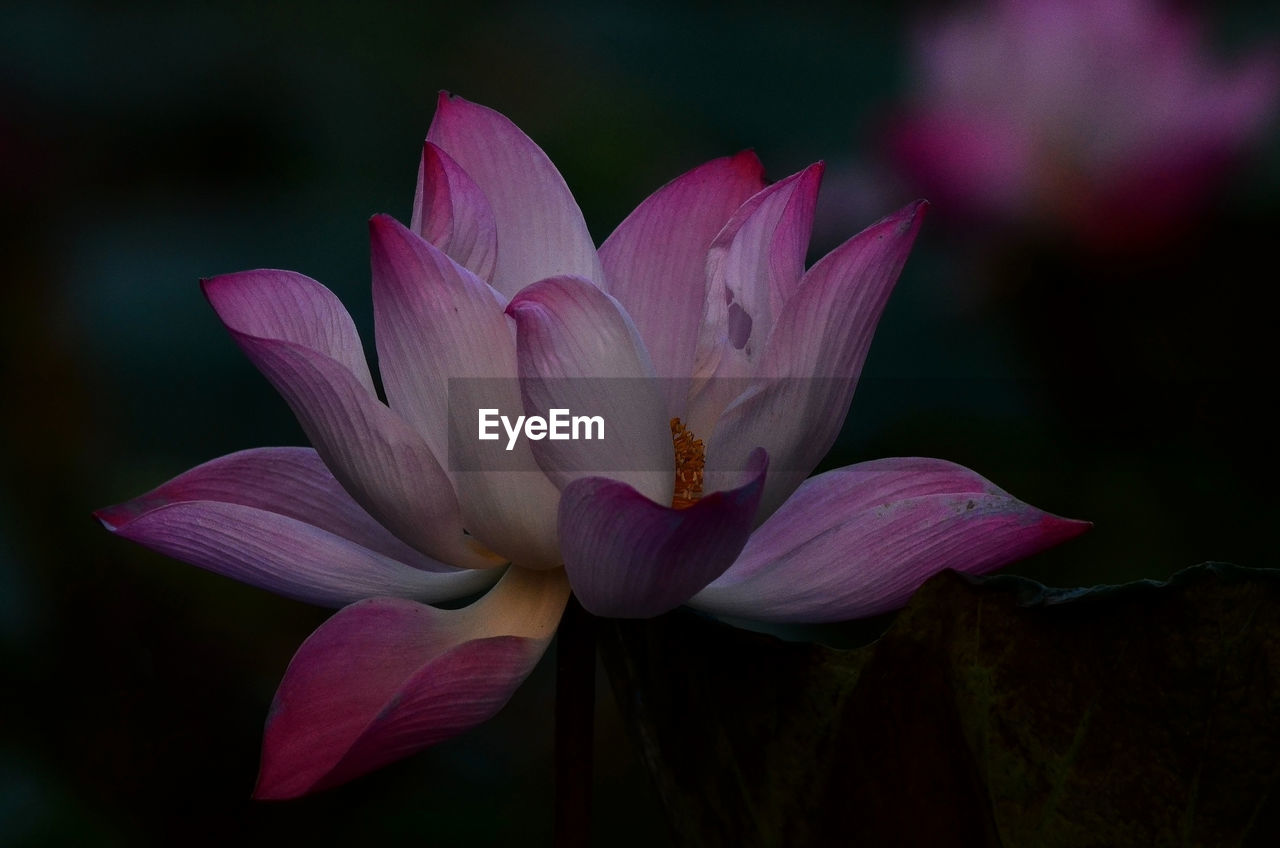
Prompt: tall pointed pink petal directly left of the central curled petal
<box><xmin>370</xmin><ymin>215</ymin><xmax>559</xmax><ymax>567</ymax></box>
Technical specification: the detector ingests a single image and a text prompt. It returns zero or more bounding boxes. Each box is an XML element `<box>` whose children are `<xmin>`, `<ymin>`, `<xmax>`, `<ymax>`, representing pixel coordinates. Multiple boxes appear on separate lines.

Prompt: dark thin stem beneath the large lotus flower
<box><xmin>556</xmin><ymin>597</ymin><xmax>595</xmax><ymax>848</ymax></box>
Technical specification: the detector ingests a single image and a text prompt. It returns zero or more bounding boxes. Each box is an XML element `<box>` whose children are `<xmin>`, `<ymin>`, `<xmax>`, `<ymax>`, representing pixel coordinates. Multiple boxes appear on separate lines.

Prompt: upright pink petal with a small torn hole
<box><xmin>687</xmin><ymin>163</ymin><xmax>823</xmax><ymax>433</ymax></box>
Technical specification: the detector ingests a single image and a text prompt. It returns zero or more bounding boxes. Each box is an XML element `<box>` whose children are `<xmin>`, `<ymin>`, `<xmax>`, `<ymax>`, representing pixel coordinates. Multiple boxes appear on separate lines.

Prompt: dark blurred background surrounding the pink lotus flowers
<box><xmin>0</xmin><ymin>0</ymin><xmax>1280</xmax><ymax>845</ymax></box>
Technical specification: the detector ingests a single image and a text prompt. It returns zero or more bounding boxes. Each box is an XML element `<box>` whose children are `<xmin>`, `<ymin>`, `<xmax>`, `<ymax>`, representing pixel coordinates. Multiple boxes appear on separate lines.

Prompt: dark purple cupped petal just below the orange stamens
<box><xmin>559</xmin><ymin>451</ymin><xmax>768</xmax><ymax>617</ymax></box>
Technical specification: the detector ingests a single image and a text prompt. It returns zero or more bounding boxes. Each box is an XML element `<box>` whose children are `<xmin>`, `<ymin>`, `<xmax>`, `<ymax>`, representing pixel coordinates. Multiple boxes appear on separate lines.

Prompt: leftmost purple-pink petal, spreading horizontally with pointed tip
<box><xmin>95</xmin><ymin>447</ymin><xmax>497</xmax><ymax>607</ymax></box>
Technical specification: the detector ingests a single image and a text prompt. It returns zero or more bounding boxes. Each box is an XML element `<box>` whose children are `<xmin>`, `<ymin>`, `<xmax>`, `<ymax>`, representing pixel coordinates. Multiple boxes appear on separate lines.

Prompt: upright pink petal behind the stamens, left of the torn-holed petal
<box><xmin>600</xmin><ymin>151</ymin><xmax>764</xmax><ymax>418</ymax></box>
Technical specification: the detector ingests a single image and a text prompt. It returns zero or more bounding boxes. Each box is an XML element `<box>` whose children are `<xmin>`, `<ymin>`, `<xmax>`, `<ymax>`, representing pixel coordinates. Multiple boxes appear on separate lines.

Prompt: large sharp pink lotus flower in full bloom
<box><xmin>97</xmin><ymin>95</ymin><xmax>1084</xmax><ymax>798</ymax></box>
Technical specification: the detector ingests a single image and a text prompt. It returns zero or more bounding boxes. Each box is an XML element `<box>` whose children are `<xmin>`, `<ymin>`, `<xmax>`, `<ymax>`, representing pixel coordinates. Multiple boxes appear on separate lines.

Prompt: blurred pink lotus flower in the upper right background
<box><xmin>891</xmin><ymin>0</ymin><xmax>1277</xmax><ymax>243</ymax></box>
